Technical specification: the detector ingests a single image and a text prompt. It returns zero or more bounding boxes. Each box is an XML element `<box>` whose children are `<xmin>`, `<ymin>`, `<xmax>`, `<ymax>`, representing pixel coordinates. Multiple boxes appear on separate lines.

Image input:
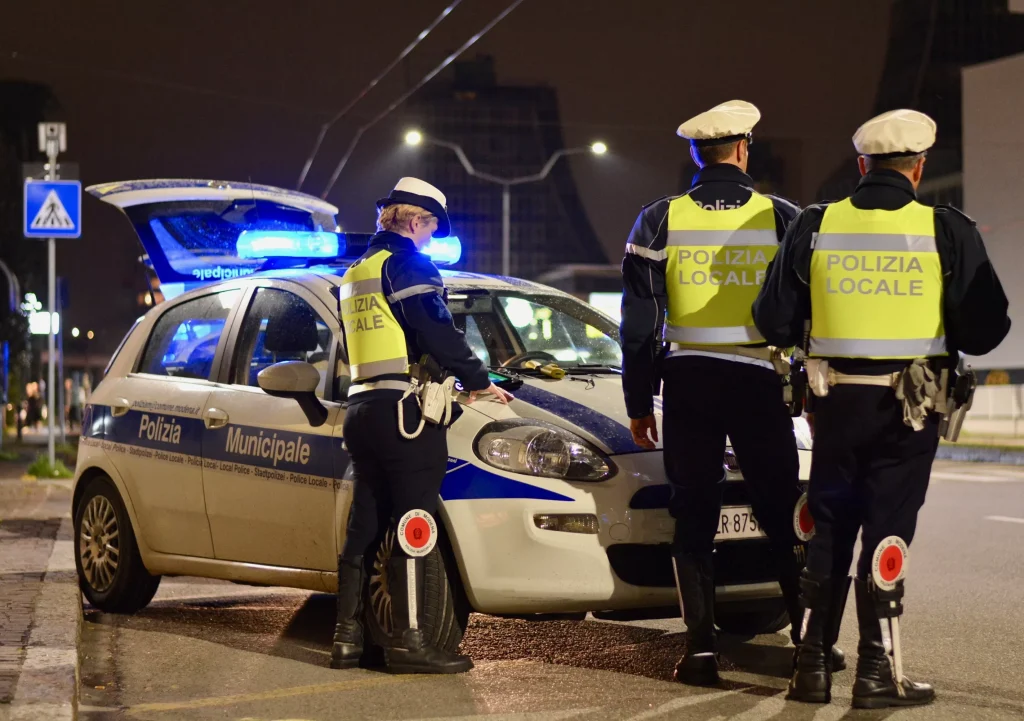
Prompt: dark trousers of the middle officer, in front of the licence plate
<box><xmin>663</xmin><ymin>355</ymin><xmax>803</xmax><ymax>555</ymax></box>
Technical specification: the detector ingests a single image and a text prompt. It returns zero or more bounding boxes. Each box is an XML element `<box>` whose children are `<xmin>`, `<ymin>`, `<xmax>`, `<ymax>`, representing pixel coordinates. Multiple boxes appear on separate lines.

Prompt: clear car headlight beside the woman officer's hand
<box><xmin>473</xmin><ymin>418</ymin><xmax>615</xmax><ymax>480</ymax></box>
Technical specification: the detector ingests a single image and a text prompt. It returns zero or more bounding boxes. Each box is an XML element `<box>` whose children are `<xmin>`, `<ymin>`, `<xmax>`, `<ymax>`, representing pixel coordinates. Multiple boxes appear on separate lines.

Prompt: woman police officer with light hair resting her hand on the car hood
<box><xmin>331</xmin><ymin>177</ymin><xmax>512</xmax><ymax>673</ymax></box>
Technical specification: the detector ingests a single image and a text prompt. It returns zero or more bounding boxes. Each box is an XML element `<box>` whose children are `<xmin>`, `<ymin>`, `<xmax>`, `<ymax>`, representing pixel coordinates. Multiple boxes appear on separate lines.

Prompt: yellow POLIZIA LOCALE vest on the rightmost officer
<box><xmin>810</xmin><ymin>198</ymin><xmax>946</xmax><ymax>361</ymax></box>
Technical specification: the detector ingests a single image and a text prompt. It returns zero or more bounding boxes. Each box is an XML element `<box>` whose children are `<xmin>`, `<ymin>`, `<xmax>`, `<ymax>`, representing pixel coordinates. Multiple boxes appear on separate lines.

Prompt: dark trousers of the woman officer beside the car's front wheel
<box><xmin>341</xmin><ymin>398</ymin><xmax>447</xmax><ymax>561</ymax></box>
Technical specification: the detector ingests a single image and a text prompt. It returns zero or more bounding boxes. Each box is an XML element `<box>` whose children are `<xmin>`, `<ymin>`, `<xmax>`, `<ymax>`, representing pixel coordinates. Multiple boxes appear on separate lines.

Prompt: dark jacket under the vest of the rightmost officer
<box><xmin>754</xmin><ymin>170</ymin><xmax>1010</xmax><ymax>374</ymax></box>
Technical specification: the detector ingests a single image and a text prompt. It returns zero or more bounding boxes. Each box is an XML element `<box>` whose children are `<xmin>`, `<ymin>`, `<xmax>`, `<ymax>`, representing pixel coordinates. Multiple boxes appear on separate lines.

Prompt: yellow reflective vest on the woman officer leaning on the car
<box><xmin>339</xmin><ymin>250</ymin><xmax>409</xmax><ymax>382</ymax></box>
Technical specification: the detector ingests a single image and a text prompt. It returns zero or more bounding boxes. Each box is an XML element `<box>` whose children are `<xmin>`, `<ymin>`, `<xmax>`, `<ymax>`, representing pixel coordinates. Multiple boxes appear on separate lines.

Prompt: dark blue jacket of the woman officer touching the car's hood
<box><xmin>339</xmin><ymin>230</ymin><xmax>490</xmax><ymax>400</ymax></box>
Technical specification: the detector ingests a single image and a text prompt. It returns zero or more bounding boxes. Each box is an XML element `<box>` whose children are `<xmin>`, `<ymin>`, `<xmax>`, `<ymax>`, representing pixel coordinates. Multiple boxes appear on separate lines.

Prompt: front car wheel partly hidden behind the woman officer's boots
<box><xmin>364</xmin><ymin>528</ymin><xmax>469</xmax><ymax>651</ymax></box>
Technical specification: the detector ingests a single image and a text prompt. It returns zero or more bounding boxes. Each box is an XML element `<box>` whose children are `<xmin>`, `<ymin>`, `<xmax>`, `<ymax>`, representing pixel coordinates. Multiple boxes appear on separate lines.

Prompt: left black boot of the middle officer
<box><xmin>673</xmin><ymin>553</ymin><xmax>722</xmax><ymax>686</ymax></box>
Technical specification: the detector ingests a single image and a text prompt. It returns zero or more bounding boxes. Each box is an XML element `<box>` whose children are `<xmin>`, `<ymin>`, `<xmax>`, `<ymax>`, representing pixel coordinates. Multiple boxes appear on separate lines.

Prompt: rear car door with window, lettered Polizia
<box><xmin>104</xmin><ymin>289</ymin><xmax>242</xmax><ymax>558</ymax></box>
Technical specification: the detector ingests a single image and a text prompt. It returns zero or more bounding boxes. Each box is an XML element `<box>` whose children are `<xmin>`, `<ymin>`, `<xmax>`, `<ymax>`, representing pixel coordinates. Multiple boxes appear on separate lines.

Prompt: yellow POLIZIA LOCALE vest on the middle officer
<box><xmin>665</xmin><ymin>193</ymin><xmax>778</xmax><ymax>345</ymax></box>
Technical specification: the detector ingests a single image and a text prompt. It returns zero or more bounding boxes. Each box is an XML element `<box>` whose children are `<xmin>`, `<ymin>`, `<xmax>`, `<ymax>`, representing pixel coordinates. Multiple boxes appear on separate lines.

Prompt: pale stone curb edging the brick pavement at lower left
<box><xmin>10</xmin><ymin>517</ymin><xmax>82</xmax><ymax>721</ymax></box>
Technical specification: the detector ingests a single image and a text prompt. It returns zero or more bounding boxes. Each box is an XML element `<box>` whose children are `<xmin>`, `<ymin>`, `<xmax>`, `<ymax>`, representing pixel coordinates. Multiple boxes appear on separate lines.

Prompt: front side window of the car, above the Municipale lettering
<box><xmin>231</xmin><ymin>288</ymin><xmax>333</xmax><ymax>398</ymax></box>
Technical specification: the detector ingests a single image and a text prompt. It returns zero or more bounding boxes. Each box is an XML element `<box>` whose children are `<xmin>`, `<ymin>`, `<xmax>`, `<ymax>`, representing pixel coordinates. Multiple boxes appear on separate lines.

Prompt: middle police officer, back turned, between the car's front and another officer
<box><xmin>621</xmin><ymin>100</ymin><xmax>839</xmax><ymax>685</ymax></box>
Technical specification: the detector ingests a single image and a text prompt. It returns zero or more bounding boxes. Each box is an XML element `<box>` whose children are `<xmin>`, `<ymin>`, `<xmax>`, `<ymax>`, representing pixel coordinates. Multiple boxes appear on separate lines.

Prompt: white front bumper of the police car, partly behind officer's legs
<box><xmin>441</xmin><ymin>452</ymin><xmax>809</xmax><ymax>613</ymax></box>
